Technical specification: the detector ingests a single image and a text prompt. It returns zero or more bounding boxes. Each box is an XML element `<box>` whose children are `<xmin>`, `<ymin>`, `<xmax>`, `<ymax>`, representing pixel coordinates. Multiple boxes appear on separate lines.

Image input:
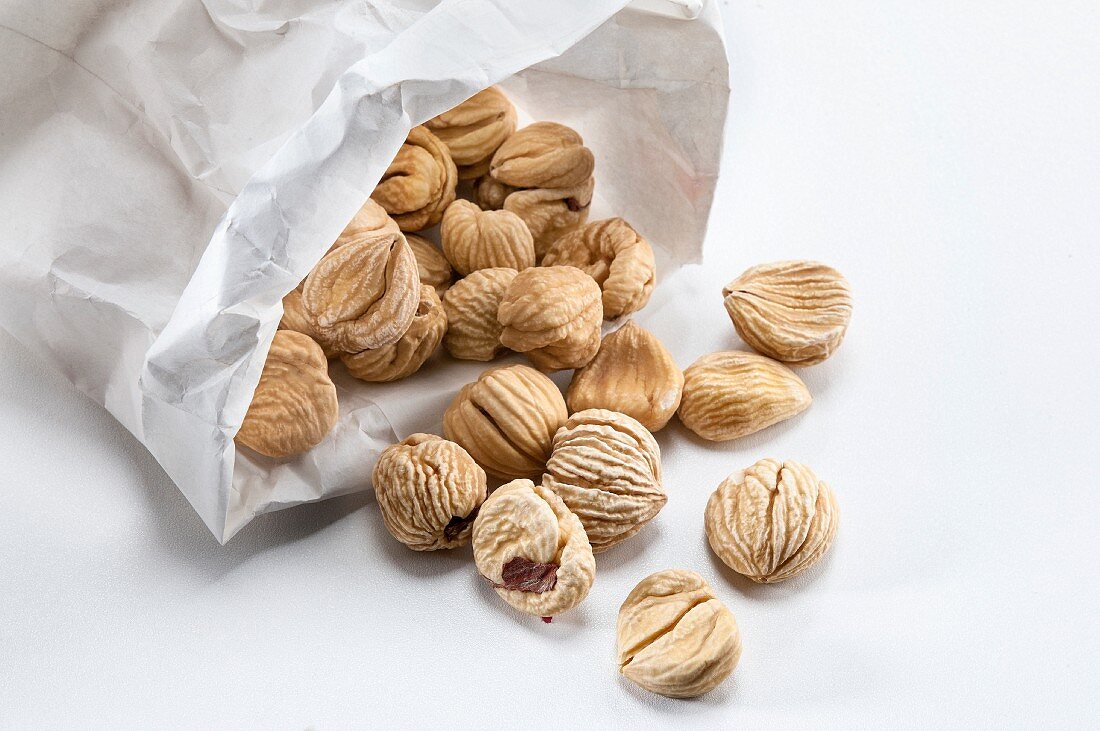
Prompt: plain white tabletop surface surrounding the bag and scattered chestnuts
<box><xmin>0</xmin><ymin>0</ymin><xmax>1100</xmax><ymax>728</ymax></box>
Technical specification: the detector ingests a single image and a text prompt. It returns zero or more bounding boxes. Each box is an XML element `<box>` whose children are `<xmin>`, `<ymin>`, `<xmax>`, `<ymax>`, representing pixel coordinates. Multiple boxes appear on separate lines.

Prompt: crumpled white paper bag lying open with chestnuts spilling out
<box><xmin>0</xmin><ymin>0</ymin><xmax>729</xmax><ymax>542</ymax></box>
